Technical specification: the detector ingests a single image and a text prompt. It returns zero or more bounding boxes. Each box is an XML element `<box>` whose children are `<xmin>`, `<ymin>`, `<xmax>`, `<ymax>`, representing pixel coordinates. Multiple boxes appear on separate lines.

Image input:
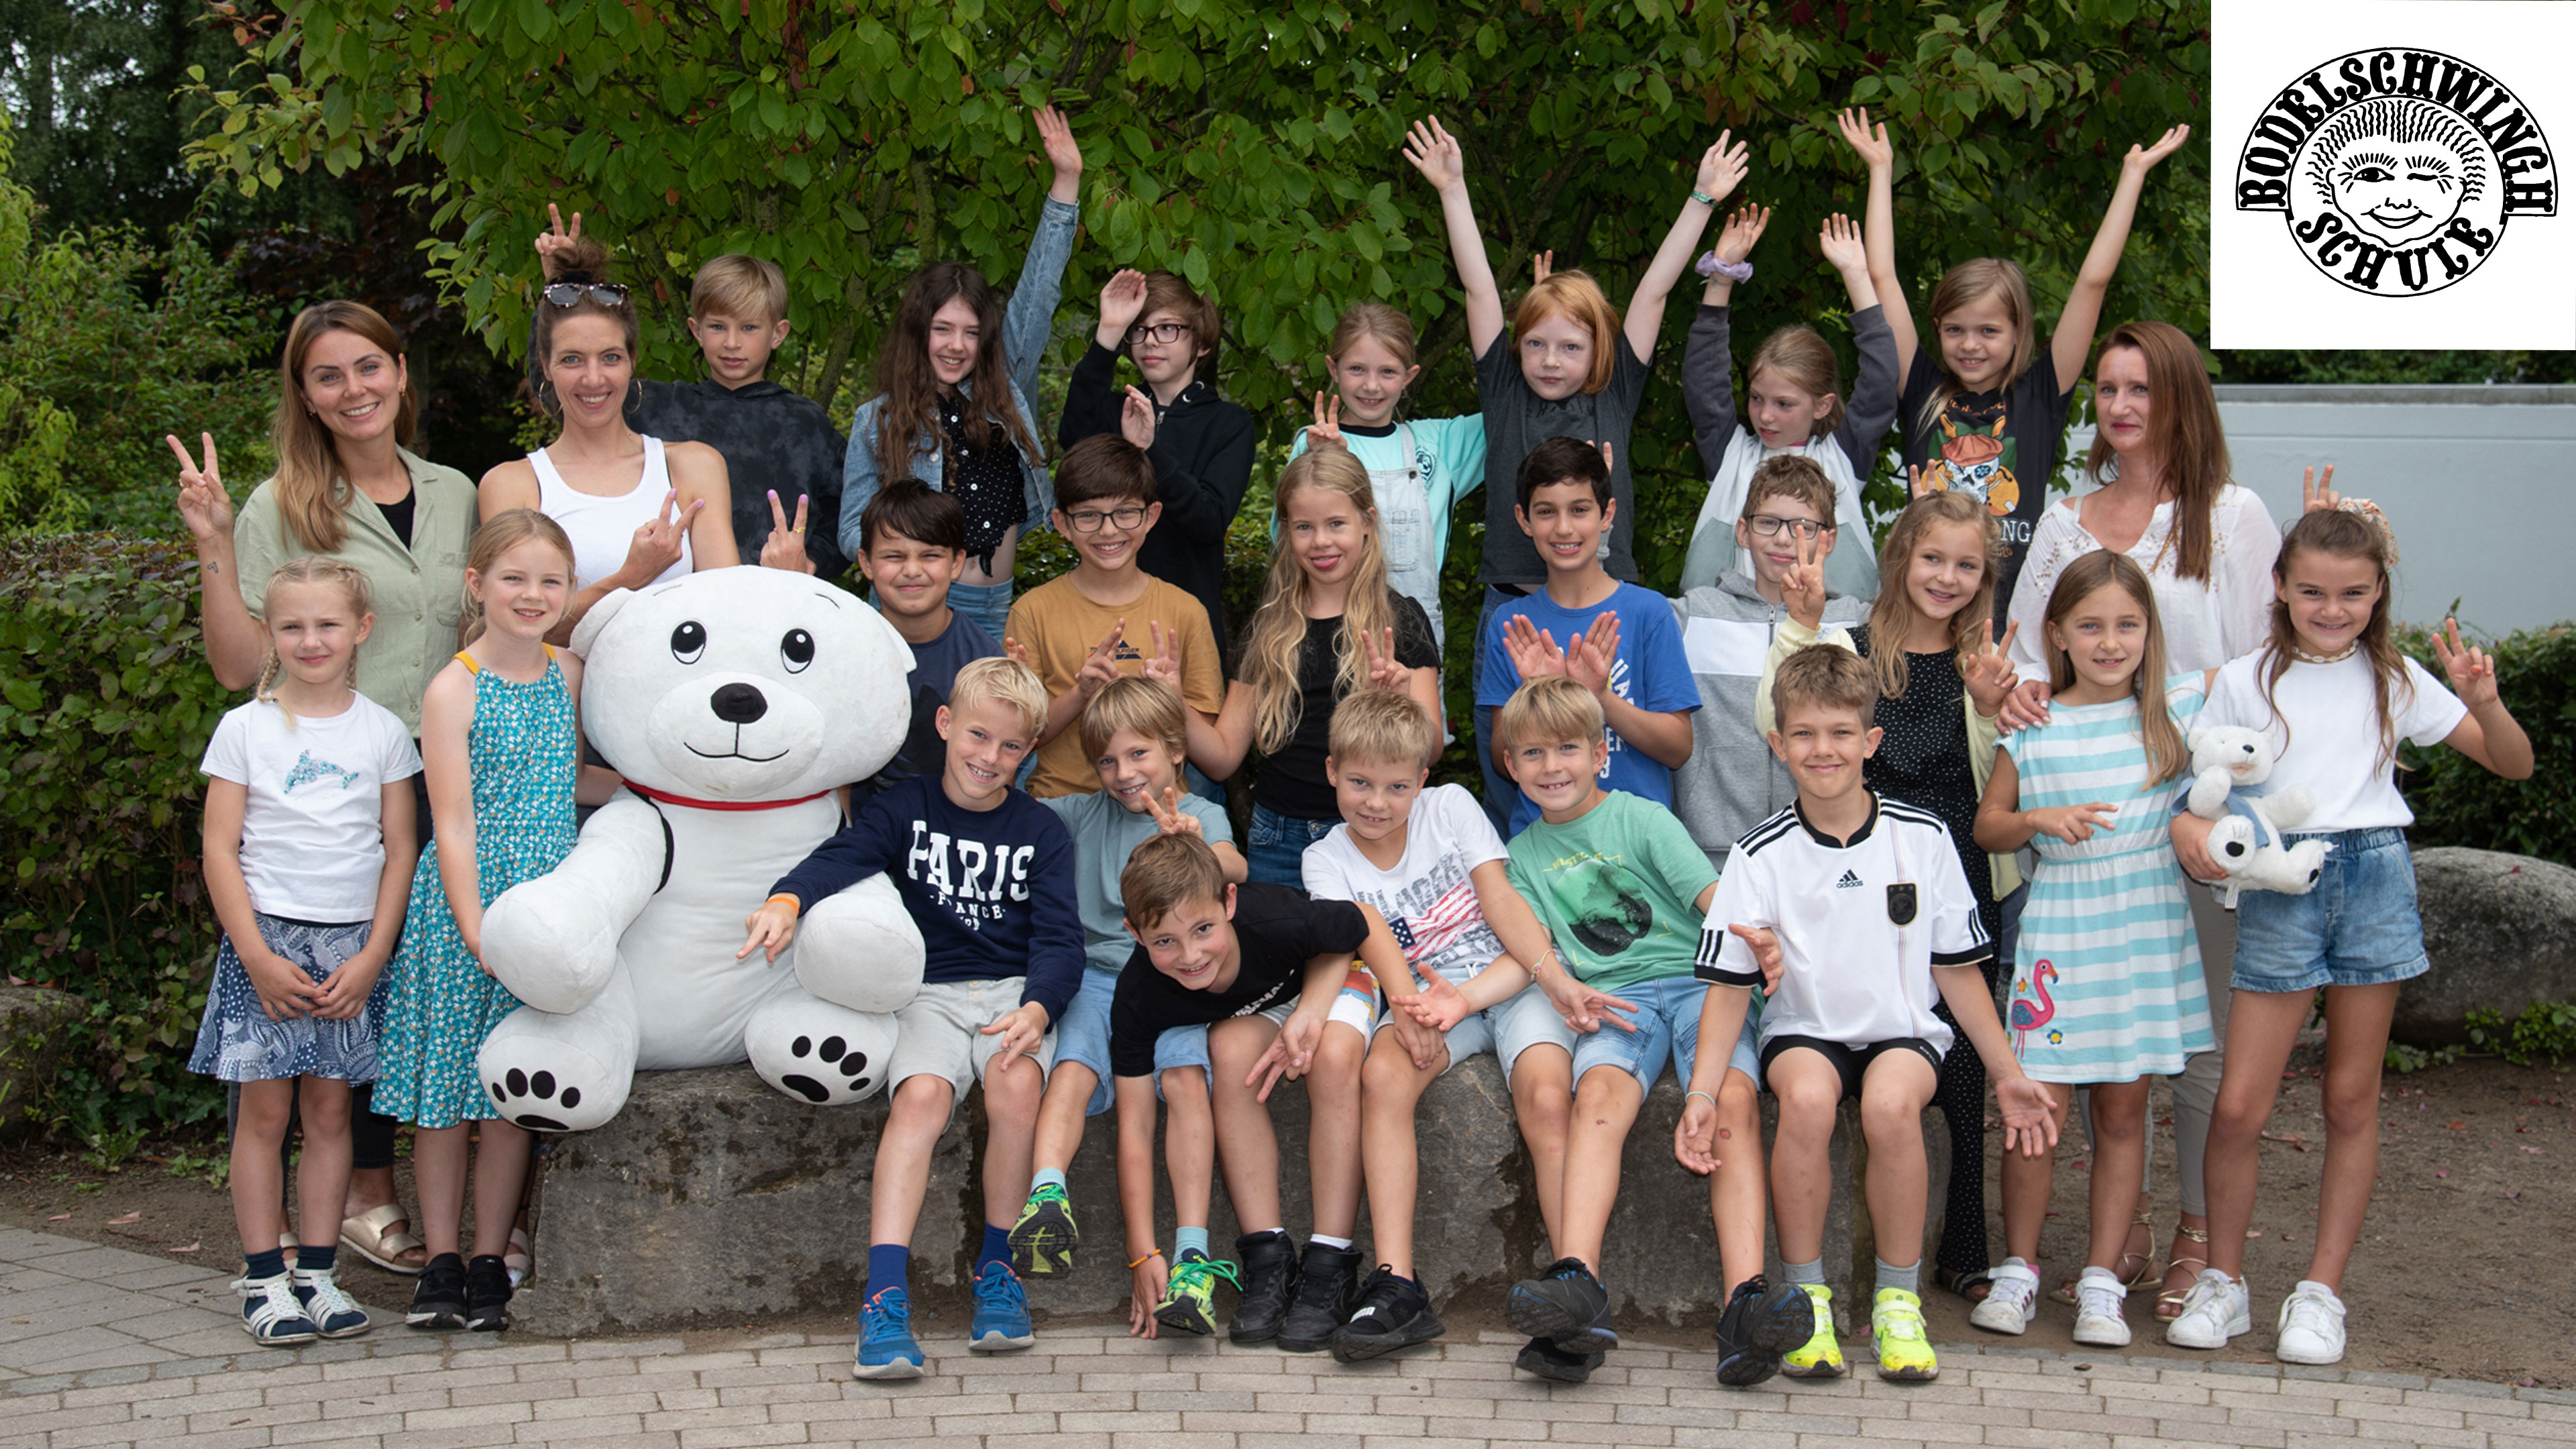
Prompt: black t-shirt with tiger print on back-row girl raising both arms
<box><xmin>1896</xmin><ymin>353</ymin><xmax>2074</xmax><ymax>624</ymax></box>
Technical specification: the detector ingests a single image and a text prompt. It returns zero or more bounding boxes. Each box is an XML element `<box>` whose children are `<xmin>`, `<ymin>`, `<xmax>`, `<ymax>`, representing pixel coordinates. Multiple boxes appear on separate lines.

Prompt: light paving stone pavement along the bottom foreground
<box><xmin>0</xmin><ymin>1227</ymin><xmax>2576</xmax><ymax>1449</ymax></box>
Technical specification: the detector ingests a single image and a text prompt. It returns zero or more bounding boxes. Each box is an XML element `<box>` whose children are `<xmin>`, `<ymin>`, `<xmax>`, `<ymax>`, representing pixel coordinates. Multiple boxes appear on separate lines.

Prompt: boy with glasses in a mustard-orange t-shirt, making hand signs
<box><xmin>1005</xmin><ymin>436</ymin><xmax>1226</xmax><ymax>799</ymax></box>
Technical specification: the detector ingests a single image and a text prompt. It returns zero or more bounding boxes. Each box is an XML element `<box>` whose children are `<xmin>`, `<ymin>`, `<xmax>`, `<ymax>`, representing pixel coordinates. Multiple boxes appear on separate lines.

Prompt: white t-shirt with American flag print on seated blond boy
<box><xmin>1306</xmin><ymin>784</ymin><xmax>1507</xmax><ymax>982</ymax></box>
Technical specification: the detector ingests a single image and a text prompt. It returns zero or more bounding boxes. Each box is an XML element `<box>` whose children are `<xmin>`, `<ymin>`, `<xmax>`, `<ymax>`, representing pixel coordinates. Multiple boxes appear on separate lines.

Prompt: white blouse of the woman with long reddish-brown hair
<box><xmin>2009</xmin><ymin>482</ymin><xmax>2279</xmax><ymax>681</ymax></box>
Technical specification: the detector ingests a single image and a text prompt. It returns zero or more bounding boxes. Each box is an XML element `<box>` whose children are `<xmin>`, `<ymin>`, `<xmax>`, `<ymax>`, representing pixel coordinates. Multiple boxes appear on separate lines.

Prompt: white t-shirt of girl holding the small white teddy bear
<box><xmin>2200</xmin><ymin>650</ymin><xmax>2468</xmax><ymax>833</ymax></box>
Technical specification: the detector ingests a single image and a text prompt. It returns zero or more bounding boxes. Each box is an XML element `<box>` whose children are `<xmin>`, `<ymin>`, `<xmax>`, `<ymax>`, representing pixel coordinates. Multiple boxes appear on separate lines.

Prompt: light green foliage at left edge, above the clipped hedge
<box><xmin>0</xmin><ymin>121</ymin><xmax>273</xmax><ymax>536</ymax></box>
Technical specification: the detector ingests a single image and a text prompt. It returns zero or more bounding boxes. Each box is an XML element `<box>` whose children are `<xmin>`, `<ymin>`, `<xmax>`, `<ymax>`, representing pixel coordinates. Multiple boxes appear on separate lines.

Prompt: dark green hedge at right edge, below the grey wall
<box><xmin>2398</xmin><ymin>613</ymin><xmax>2576</xmax><ymax>866</ymax></box>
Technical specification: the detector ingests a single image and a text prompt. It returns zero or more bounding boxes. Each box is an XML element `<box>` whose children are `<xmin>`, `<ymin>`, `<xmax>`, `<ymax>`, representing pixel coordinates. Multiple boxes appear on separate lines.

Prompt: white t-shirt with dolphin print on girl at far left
<box><xmin>199</xmin><ymin>694</ymin><xmax>420</xmax><ymax>923</ymax></box>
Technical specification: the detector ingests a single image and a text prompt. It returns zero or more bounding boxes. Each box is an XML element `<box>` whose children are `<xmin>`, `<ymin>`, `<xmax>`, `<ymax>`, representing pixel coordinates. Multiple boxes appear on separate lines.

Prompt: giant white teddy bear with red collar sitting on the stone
<box><xmin>476</xmin><ymin>568</ymin><xmax>922</xmax><ymax>1132</ymax></box>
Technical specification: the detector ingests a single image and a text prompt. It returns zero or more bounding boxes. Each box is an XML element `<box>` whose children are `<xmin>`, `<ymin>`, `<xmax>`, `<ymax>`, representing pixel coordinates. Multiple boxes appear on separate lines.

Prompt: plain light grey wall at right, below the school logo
<box><xmin>2066</xmin><ymin>387</ymin><xmax>2576</xmax><ymax>634</ymax></box>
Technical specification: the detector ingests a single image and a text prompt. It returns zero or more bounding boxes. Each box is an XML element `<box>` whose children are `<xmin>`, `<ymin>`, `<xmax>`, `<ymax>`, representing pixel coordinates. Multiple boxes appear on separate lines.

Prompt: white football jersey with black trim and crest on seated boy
<box><xmin>1698</xmin><ymin>799</ymin><xmax>1994</xmax><ymax>1052</ymax></box>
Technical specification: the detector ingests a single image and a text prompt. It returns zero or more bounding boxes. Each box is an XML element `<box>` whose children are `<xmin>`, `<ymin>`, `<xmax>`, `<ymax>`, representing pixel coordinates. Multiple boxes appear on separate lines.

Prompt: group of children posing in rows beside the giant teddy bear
<box><xmin>199</xmin><ymin>96</ymin><xmax>2532</xmax><ymax>1385</ymax></box>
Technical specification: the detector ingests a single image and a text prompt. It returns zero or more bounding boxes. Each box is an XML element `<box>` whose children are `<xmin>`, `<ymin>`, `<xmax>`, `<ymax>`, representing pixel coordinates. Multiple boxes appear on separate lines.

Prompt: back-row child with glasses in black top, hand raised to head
<box><xmin>1056</xmin><ymin>271</ymin><xmax>1254</xmax><ymax>647</ymax></box>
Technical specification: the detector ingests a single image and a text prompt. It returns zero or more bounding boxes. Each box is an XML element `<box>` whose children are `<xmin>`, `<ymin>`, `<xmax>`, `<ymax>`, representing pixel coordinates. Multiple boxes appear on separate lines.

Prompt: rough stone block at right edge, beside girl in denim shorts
<box><xmin>2388</xmin><ymin>846</ymin><xmax>2576</xmax><ymax>1046</ymax></box>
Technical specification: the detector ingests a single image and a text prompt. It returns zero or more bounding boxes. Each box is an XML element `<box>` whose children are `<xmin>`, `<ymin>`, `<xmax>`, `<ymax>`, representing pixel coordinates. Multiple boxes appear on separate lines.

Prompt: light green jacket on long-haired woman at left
<box><xmin>232</xmin><ymin>451</ymin><xmax>476</xmax><ymax>737</ymax></box>
